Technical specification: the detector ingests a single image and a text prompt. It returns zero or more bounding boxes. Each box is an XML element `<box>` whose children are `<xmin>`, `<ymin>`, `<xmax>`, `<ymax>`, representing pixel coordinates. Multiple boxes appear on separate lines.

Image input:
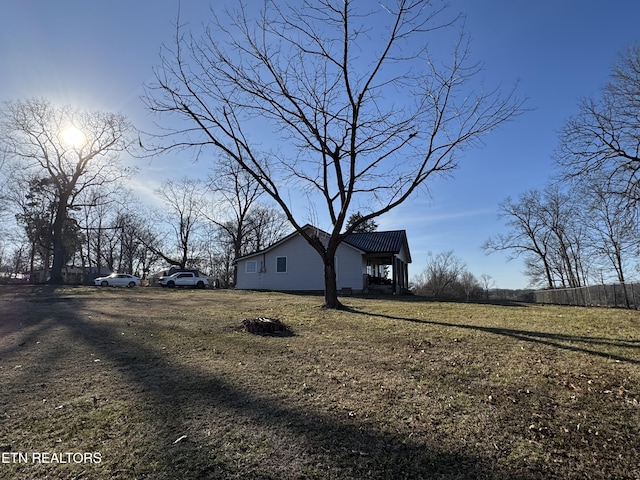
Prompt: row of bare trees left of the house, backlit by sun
<box><xmin>0</xmin><ymin>99</ymin><xmax>287</xmax><ymax>285</ymax></box>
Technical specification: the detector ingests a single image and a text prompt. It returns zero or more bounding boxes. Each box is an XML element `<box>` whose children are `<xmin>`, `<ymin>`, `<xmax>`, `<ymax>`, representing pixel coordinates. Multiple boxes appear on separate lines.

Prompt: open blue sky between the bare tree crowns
<box><xmin>0</xmin><ymin>0</ymin><xmax>640</xmax><ymax>288</ymax></box>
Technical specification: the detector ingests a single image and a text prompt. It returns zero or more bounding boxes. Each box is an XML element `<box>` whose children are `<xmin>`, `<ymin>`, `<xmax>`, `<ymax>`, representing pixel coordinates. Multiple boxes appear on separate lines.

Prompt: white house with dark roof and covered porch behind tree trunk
<box><xmin>235</xmin><ymin>225</ymin><xmax>411</xmax><ymax>293</ymax></box>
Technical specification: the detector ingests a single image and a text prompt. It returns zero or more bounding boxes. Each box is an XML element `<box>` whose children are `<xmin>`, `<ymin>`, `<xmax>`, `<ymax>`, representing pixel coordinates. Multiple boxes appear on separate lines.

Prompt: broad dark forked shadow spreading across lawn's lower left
<box><xmin>0</xmin><ymin>292</ymin><xmax>533</xmax><ymax>479</ymax></box>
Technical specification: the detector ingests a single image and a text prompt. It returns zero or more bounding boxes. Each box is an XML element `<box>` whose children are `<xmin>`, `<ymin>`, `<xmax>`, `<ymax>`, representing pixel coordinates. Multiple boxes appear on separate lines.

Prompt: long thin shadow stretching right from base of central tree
<box><xmin>348</xmin><ymin>307</ymin><xmax>640</xmax><ymax>365</ymax></box>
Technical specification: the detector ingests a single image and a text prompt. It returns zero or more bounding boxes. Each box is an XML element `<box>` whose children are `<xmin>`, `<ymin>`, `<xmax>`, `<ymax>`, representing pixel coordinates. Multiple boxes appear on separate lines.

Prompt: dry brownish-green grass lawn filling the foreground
<box><xmin>0</xmin><ymin>286</ymin><xmax>640</xmax><ymax>480</ymax></box>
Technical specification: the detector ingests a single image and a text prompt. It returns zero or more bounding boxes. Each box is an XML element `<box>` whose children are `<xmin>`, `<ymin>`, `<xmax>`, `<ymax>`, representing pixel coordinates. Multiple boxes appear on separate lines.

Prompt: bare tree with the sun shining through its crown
<box><xmin>0</xmin><ymin>99</ymin><xmax>132</xmax><ymax>284</ymax></box>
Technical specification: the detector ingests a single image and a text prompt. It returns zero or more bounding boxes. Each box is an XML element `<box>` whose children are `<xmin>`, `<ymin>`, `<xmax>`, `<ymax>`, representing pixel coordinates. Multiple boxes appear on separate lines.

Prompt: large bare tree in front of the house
<box><xmin>147</xmin><ymin>0</ymin><xmax>522</xmax><ymax>308</ymax></box>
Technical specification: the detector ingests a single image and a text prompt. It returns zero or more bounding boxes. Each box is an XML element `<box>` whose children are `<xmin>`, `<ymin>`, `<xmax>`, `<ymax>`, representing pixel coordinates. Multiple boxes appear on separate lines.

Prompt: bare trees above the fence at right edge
<box><xmin>483</xmin><ymin>46</ymin><xmax>640</xmax><ymax>289</ymax></box>
